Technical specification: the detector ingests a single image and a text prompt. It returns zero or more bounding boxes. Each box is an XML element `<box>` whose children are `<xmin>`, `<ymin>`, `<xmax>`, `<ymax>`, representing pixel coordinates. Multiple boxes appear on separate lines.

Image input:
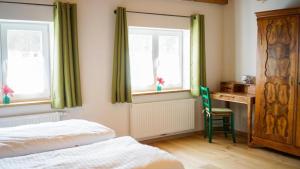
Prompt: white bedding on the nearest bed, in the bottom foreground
<box><xmin>0</xmin><ymin>136</ymin><xmax>184</xmax><ymax>169</ymax></box>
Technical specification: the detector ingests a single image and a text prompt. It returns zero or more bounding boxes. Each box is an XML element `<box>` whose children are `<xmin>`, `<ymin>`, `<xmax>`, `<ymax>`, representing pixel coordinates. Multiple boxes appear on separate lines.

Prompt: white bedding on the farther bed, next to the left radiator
<box><xmin>0</xmin><ymin>120</ymin><xmax>115</xmax><ymax>158</ymax></box>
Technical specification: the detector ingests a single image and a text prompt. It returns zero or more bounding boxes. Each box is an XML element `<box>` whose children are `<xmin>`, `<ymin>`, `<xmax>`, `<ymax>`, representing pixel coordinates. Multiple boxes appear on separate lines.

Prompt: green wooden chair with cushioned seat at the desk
<box><xmin>200</xmin><ymin>86</ymin><xmax>236</xmax><ymax>143</ymax></box>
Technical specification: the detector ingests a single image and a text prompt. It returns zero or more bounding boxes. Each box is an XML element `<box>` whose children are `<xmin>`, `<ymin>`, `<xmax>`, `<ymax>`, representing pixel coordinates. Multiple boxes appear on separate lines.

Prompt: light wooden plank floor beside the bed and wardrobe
<box><xmin>150</xmin><ymin>135</ymin><xmax>300</xmax><ymax>169</ymax></box>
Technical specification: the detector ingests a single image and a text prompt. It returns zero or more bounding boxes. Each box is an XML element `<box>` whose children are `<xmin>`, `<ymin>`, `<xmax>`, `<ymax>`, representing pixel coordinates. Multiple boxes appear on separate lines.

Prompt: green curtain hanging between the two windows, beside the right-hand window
<box><xmin>112</xmin><ymin>7</ymin><xmax>131</xmax><ymax>103</ymax></box>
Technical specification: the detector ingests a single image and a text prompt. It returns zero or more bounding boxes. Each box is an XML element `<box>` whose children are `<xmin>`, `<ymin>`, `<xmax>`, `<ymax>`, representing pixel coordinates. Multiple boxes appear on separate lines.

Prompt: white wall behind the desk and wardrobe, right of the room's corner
<box><xmin>222</xmin><ymin>0</ymin><xmax>300</xmax><ymax>131</ymax></box>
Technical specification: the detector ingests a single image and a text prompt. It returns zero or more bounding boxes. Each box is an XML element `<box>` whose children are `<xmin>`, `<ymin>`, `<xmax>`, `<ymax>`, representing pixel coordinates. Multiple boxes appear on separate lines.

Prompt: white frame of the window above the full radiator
<box><xmin>129</xmin><ymin>26</ymin><xmax>189</xmax><ymax>93</ymax></box>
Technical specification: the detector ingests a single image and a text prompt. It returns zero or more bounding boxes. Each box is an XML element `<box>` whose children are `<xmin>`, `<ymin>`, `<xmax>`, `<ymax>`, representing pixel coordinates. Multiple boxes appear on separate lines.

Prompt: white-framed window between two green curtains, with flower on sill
<box><xmin>129</xmin><ymin>27</ymin><xmax>189</xmax><ymax>92</ymax></box>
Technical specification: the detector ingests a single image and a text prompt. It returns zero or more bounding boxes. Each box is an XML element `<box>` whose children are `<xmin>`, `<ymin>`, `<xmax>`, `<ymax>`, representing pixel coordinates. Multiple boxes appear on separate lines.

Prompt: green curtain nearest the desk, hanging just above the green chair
<box><xmin>191</xmin><ymin>14</ymin><xmax>206</xmax><ymax>96</ymax></box>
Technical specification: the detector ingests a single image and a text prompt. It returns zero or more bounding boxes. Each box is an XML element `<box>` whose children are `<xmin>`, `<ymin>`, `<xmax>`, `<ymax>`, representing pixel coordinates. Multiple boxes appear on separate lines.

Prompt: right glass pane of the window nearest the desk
<box><xmin>157</xmin><ymin>36</ymin><xmax>181</xmax><ymax>88</ymax></box>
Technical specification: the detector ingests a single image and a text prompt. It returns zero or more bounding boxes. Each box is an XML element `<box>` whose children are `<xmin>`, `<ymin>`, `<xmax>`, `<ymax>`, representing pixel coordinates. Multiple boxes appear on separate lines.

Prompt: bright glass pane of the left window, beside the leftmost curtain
<box><xmin>6</xmin><ymin>30</ymin><xmax>47</xmax><ymax>95</ymax></box>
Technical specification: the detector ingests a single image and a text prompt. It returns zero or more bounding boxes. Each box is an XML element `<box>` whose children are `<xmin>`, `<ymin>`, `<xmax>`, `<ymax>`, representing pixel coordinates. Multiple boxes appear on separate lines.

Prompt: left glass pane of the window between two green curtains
<box><xmin>129</xmin><ymin>34</ymin><xmax>154</xmax><ymax>90</ymax></box>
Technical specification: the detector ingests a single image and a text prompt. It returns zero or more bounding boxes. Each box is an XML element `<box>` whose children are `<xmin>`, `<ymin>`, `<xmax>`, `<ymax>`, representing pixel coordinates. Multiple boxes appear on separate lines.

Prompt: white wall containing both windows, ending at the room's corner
<box><xmin>0</xmin><ymin>0</ymin><xmax>223</xmax><ymax>135</ymax></box>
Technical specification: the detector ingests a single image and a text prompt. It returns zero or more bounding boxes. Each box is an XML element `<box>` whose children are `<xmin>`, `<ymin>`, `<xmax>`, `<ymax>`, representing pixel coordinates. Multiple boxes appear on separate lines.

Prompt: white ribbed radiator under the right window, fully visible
<box><xmin>130</xmin><ymin>99</ymin><xmax>195</xmax><ymax>140</ymax></box>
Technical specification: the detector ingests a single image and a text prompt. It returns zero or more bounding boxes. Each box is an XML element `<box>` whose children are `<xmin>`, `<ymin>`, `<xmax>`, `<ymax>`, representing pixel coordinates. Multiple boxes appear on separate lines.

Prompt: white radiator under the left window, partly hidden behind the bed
<box><xmin>0</xmin><ymin>112</ymin><xmax>63</xmax><ymax>127</ymax></box>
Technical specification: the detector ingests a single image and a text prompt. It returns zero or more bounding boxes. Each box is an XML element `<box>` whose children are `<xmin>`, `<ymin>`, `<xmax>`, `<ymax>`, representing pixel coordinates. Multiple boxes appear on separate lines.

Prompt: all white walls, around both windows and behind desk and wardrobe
<box><xmin>0</xmin><ymin>0</ymin><xmax>300</xmax><ymax>135</ymax></box>
